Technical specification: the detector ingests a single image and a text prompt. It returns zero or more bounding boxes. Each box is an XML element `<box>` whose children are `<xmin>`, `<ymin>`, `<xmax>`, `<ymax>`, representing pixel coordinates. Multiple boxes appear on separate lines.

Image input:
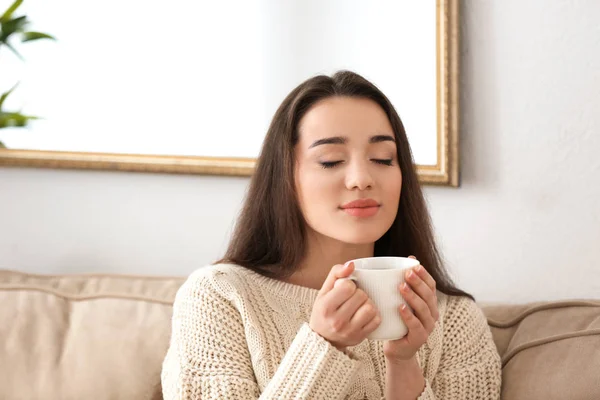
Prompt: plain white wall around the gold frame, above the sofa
<box><xmin>0</xmin><ymin>0</ymin><xmax>600</xmax><ymax>302</ymax></box>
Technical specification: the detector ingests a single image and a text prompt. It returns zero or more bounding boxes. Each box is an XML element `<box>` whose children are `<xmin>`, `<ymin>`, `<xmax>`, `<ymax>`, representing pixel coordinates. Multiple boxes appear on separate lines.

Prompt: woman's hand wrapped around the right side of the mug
<box><xmin>383</xmin><ymin>256</ymin><xmax>439</xmax><ymax>363</ymax></box>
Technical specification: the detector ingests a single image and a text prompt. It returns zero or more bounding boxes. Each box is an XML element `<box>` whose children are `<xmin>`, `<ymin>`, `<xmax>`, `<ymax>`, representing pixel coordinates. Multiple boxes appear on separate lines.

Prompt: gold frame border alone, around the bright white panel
<box><xmin>0</xmin><ymin>0</ymin><xmax>459</xmax><ymax>187</ymax></box>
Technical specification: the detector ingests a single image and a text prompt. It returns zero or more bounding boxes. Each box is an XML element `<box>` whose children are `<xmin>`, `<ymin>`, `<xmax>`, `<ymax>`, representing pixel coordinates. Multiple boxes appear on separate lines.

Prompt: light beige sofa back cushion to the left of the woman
<box><xmin>0</xmin><ymin>271</ymin><xmax>184</xmax><ymax>400</ymax></box>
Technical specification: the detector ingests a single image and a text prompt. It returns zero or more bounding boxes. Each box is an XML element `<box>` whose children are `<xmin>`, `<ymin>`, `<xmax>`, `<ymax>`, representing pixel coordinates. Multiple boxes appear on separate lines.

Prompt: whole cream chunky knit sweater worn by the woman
<box><xmin>162</xmin><ymin>264</ymin><xmax>501</xmax><ymax>400</ymax></box>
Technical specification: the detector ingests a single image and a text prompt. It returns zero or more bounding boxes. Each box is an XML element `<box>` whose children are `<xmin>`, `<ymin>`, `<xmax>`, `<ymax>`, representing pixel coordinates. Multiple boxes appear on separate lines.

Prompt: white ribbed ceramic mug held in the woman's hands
<box><xmin>338</xmin><ymin>257</ymin><xmax>420</xmax><ymax>340</ymax></box>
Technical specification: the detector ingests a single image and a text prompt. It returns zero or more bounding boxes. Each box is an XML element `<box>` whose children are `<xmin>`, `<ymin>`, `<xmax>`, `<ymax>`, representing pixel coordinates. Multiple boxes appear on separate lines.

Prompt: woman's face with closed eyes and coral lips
<box><xmin>295</xmin><ymin>96</ymin><xmax>402</xmax><ymax>244</ymax></box>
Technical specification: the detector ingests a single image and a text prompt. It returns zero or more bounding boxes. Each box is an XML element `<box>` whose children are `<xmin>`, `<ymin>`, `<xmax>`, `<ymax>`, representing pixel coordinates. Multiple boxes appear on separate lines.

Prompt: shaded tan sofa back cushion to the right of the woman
<box><xmin>482</xmin><ymin>300</ymin><xmax>600</xmax><ymax>400</ymax></box>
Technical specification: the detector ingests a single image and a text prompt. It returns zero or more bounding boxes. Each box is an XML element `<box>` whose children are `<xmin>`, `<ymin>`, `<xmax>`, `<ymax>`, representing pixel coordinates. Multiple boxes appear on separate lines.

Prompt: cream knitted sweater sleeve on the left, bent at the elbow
<box><xmin>161</xmin><ymin>270</ymin><xmax>359</xmax><ymax>400</ymax></box>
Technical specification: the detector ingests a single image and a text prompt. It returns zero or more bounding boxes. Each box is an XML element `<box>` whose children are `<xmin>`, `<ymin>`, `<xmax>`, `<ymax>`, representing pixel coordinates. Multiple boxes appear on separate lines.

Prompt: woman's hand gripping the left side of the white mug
<box><xmin>309</xmin><ymin>263</ymin><xmax>381</xmax><ymax>351</ymax></box>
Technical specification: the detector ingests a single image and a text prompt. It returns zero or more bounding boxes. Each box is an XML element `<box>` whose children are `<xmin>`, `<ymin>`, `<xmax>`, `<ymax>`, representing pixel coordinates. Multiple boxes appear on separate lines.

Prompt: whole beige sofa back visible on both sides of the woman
<box><xmin>0</xmin><ymin>271</ymin><xmax>600</xmax><ymax>400</ymax></box>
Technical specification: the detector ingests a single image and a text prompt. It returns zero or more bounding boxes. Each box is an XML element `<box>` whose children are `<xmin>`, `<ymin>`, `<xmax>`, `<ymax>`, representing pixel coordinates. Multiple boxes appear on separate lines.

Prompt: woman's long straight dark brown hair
<box><xmin>218</xmin><ymin>71</ymin><xmax>473</xmax><ymax>298</ymax></box>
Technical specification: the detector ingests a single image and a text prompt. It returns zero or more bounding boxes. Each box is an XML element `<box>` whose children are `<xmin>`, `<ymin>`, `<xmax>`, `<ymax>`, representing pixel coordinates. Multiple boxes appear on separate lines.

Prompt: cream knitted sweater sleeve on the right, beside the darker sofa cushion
<box><xmin>418</xmin><ymin>297</ymin><xmax>502</xmax><ymax>400</ymax></box>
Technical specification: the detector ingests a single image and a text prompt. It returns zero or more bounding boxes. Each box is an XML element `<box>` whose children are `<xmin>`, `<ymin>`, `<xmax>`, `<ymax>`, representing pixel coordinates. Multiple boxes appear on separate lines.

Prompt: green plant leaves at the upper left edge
<box><xmin>0</xmin><ymin>0</ymin><xmax>55</xmax><ymax>148</ymax></box>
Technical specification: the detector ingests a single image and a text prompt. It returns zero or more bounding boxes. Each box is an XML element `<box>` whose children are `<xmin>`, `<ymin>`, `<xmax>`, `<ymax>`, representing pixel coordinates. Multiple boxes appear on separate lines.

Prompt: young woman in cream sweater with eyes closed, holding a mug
<box><xmin>162</xmin><ymin>71</ymin><xmax>501</xmax><ymax>400</ymax></box>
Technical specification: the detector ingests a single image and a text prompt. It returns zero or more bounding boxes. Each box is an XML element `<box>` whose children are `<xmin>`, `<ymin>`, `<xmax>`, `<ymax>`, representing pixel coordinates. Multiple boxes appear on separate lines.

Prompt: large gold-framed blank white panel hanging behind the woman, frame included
<box><xmin>0</xmin><ymin>0</ymin><xmax>459</xmax><ymax>186</ymax></box>
